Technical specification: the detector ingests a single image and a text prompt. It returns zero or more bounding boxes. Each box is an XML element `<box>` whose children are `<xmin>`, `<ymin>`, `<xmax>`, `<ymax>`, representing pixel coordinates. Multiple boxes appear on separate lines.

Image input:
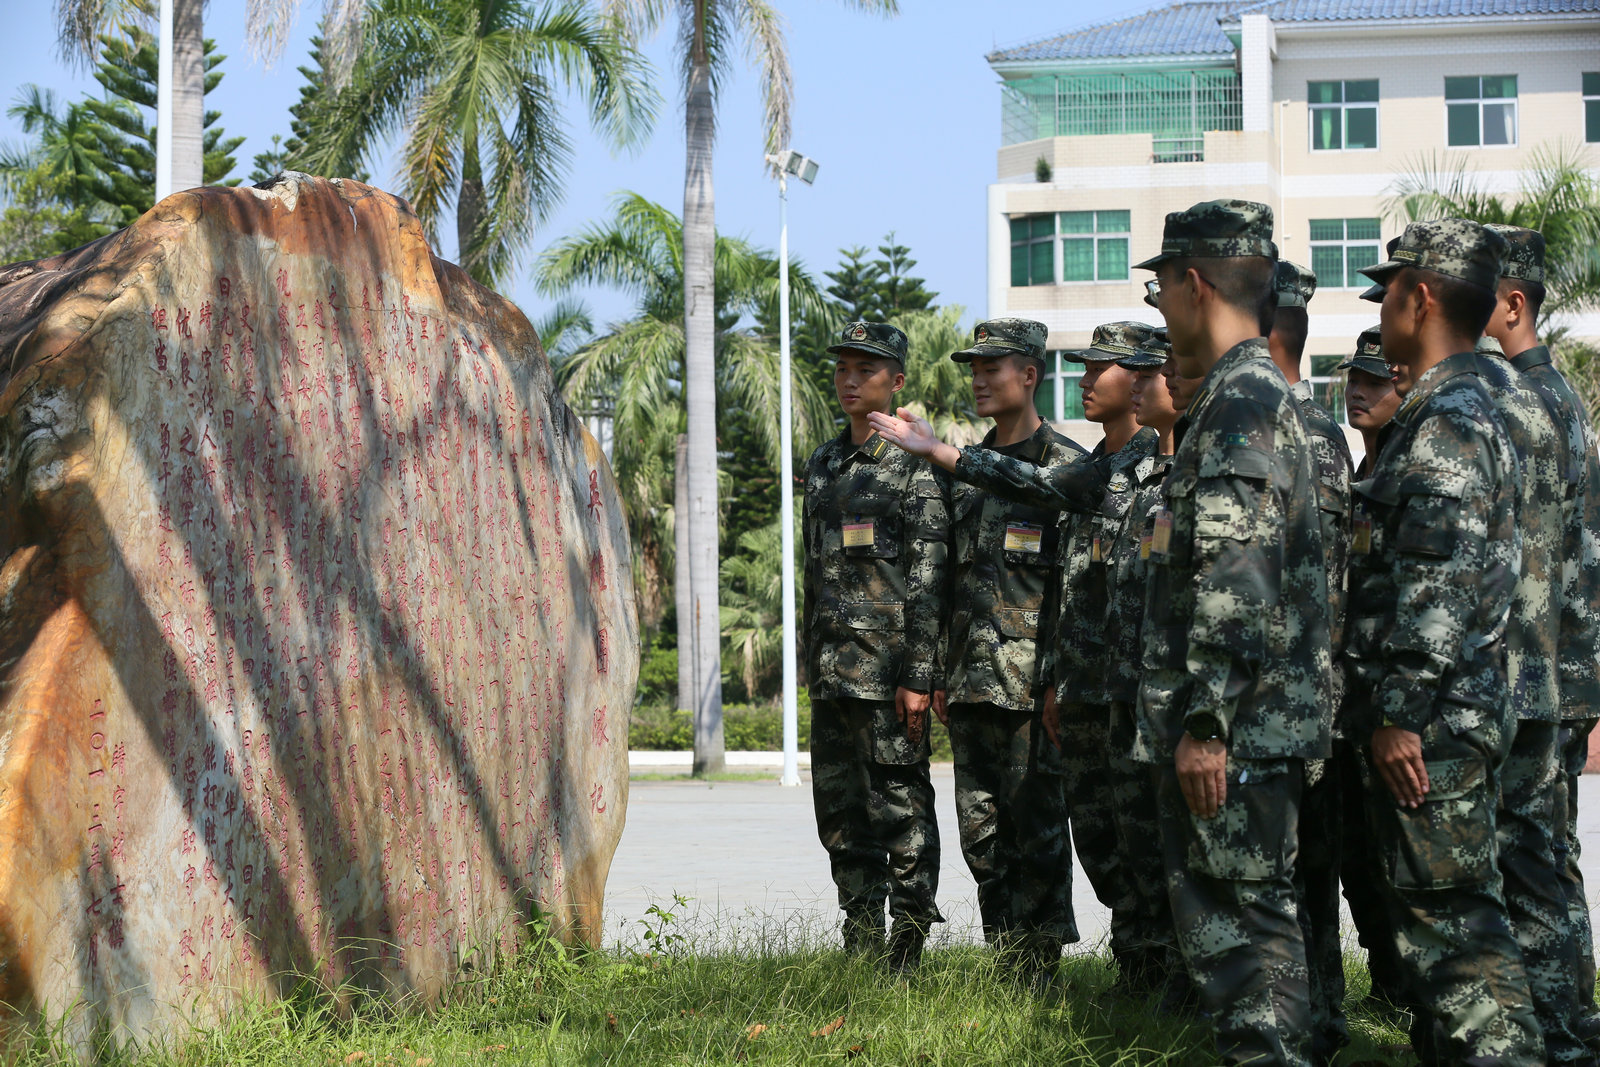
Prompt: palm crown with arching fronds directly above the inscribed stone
<box><xmin>299</xmin><ymin>0</ymin><xmax>656</xmax><ymax>285</ymax></box>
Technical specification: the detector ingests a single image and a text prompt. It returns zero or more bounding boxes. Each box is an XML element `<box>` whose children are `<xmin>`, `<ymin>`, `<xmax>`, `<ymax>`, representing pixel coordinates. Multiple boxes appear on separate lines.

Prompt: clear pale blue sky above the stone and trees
<box><xmin>9</xmin><ymin>0</ymin><xmax>1155</xmax><ymax>323</ymax></box>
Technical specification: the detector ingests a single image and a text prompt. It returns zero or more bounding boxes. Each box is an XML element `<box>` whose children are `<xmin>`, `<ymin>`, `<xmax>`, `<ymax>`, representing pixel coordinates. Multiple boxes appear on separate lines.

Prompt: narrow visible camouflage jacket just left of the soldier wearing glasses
<box><xmin>1094</xmin><ymin>427</ymin><xmax>1173</xmax><ymax>710</ymax></box>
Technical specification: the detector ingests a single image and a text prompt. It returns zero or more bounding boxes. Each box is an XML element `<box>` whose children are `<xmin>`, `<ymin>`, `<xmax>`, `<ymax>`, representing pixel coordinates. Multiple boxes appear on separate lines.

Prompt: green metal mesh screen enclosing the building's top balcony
<box><xmin>1000</xmin><ymin>70</ymin><xmax>1243</xmax><ymax>154</ymax></box>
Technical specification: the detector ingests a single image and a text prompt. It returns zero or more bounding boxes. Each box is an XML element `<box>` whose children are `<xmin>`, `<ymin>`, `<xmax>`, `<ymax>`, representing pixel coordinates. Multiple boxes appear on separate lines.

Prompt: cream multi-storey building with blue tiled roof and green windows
<box><xmin>987</xmin><ymin>0</ymin><xmax>1600</xmax><ymax>442</ymax></box>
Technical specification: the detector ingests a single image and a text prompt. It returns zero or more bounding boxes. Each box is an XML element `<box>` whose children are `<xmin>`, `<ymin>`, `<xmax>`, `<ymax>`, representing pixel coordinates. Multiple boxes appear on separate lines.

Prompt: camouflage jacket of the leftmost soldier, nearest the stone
<box><xmin>803</xmin><ymin>429</ymin><xmax>950</xmax><ymax>701</ymax></box>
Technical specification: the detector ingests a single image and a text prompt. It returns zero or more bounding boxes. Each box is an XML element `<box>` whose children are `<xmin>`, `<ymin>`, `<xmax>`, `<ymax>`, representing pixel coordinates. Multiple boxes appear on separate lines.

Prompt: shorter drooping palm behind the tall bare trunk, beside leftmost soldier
<box><xmin>534</xmin><ymin>194</ymin><xmax>832</xmax><ymax>707</ymax></box>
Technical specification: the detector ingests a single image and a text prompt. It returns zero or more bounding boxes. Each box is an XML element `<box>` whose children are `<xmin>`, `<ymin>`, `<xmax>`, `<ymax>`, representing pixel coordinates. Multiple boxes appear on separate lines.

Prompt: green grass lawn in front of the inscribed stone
<box><xmin>11</xmin><ymin>909</ymin><xmax>1408</xmax><ymax>1067</ymax></box>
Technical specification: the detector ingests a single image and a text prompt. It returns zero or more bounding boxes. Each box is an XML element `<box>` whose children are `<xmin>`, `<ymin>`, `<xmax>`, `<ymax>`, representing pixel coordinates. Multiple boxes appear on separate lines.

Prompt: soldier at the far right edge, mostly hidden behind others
<box><xmin>1488</xmin><ymin>226</ymin><xmax>1600</xmax><ymax>1061</ymax></box>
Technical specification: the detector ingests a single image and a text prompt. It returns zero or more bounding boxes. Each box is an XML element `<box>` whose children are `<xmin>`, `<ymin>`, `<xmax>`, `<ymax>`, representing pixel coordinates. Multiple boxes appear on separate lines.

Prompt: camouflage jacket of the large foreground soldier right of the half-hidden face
<box><xmin>1342</xmin><ymin>352</ymin><xmax>1522</xmax><ymax>739</ymax></box>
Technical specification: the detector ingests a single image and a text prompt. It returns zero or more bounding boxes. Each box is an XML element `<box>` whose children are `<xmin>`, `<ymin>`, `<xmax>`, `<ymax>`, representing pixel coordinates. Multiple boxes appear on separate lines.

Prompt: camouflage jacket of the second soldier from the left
<box><xmin>949</xmin><ymin>422</ymin><xmax>1098</xmax><ymax>710</ymax></box>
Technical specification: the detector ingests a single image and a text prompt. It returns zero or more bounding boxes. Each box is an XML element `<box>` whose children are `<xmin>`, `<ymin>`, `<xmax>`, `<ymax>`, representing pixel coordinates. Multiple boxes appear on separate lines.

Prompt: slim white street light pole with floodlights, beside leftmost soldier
<box><xmin>766</xmin><ymin>150</ymin><xmax>816</xmax><ymax>785</ymax></box>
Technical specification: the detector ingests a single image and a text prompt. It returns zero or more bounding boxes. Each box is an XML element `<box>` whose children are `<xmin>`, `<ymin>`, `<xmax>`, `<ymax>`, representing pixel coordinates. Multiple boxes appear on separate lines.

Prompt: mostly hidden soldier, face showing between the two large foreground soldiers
<box><xmin>1333</xmin><ymin>326</ymin><xmax>1405</xmax><ymax>1008</ymax></box>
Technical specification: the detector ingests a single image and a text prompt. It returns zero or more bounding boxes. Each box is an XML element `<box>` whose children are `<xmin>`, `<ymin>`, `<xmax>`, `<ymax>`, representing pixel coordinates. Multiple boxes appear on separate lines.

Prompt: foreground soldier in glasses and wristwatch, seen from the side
<box><xmin>1136</xmin><ymin>200</ymin><xmax>1331</xmax><ymax>1064</ymax></box>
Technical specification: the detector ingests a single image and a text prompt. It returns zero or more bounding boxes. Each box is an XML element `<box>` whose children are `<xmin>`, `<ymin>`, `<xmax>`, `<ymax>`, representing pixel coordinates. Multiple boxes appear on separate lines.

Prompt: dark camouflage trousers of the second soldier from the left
<box><xmin>949</xmin><ymin>704</ymin><xmax>1078</xmax><ymax>953</ymax></box>
